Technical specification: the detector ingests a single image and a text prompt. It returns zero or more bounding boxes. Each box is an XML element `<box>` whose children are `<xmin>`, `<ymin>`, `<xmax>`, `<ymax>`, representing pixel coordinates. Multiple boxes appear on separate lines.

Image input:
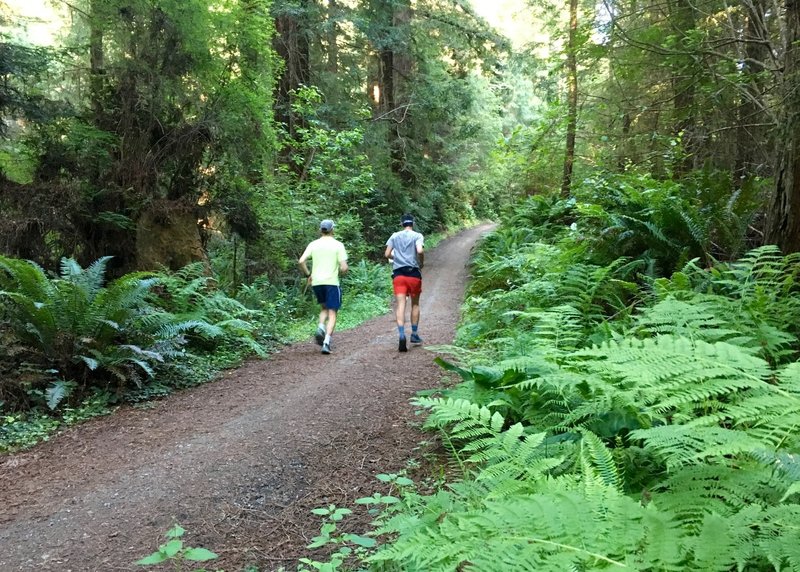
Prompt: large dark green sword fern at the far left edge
<box><xmin>0</xmin><ymin>257</ymin><xmax>163</xmax><ymax>394</ymax></box>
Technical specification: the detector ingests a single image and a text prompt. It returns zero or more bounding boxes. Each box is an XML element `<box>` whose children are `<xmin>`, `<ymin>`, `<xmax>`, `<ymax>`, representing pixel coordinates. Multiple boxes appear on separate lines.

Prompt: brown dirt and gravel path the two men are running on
<box><xmin>0</xmin><ymin>225</ymin><xmax>490</xmax><ymax>572</ymax></box>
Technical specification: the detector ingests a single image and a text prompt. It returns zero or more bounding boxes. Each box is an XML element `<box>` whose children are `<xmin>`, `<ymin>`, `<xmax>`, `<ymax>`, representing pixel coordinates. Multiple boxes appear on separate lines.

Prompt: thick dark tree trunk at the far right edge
<box><xmin>765</xmin><ymin>0</ymin><xmax>800</xmax><ymax>253</ymax></box>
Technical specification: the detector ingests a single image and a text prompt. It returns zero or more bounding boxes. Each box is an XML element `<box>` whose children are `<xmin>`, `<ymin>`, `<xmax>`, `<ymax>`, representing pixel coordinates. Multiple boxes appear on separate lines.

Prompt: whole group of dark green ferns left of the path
<box><xmin>0</xmin><ymin>257</ymin><xmax>270</xmax><ymax>409</ymax></box>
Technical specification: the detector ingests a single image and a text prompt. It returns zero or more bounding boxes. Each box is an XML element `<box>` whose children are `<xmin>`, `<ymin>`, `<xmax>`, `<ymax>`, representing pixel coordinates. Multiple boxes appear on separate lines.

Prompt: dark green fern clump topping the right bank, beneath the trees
<box><xmin>575</xmin><ymin>171</ymin><xmax>764</xmax><ymax>276</ymax></box>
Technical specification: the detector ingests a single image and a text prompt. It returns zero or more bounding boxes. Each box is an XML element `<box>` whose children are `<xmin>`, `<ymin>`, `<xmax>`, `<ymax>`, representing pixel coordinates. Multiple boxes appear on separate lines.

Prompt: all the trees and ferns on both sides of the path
<box><xmin>0</xmin><ymin>0</ymin><xmax>800</xmax><ymax>571</ymax></box>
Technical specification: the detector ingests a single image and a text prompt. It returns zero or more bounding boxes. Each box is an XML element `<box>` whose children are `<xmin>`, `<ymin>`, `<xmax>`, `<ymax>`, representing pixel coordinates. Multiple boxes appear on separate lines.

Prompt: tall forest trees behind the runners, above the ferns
<box><xmin>0</xmin><ymin>0</ymin><xmax>798</xmax><ymax>278</ymax></box>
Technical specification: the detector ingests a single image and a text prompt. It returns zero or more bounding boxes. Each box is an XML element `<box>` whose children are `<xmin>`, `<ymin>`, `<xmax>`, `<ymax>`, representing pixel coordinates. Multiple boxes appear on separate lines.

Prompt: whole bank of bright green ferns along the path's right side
<box><xmin>354</xmin><ymin>189</ymin><xmax>800</xmax><ymax>572</ymax></box>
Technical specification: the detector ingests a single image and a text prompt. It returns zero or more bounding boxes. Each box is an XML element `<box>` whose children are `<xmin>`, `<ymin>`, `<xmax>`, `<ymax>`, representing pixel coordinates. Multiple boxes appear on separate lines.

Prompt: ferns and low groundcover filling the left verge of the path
<box><xmin>0</xmin><ymin>258</ymin><xmax>391</xmax><ymax>452</ymax></box>
